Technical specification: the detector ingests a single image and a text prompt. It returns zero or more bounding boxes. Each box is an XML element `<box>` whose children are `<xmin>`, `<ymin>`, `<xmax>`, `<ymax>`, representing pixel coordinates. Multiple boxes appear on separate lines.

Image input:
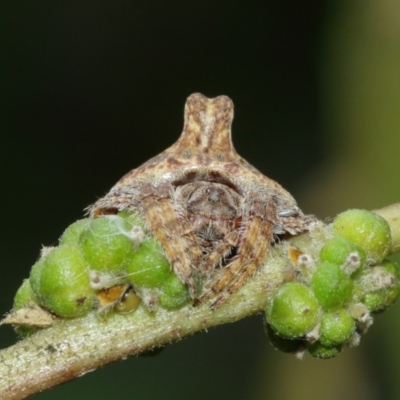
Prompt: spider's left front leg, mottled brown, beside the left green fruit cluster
<box><xmin>142</xmin><ymin>184</ymin><xmax>201</xmax><ymax>299</ymax></box>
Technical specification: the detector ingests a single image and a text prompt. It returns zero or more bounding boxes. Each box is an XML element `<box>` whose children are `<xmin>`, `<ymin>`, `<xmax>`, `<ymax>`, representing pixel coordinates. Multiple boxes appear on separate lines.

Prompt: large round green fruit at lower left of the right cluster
<box><xmin>266</xmin><ymin>282</ymin><xmax>319</xmax><ymax>339</ymax></box>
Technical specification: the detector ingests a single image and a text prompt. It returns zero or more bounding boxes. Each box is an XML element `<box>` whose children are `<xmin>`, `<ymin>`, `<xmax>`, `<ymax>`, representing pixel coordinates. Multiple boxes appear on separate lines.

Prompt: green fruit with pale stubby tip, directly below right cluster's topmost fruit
<box><xmin>319</xmin><ymin>236</ymin><xmax>366</xmax><ymax>273</ymax></box>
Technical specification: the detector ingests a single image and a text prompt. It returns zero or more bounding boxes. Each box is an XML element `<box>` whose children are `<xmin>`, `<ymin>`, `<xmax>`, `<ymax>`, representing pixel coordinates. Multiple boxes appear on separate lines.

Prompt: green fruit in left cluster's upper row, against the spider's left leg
<box><xmin>126</xmin><ymin>239</ymin><xmax>172</xmax><ymax>288</ymax></box>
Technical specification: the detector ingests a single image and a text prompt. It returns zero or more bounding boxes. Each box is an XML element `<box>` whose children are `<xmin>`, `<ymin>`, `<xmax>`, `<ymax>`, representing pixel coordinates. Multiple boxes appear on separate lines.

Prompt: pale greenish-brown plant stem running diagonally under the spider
<box><xmin>0</xmin><ymin>204</ymin><xmax>400</xmax><ymax>400</ymax></box>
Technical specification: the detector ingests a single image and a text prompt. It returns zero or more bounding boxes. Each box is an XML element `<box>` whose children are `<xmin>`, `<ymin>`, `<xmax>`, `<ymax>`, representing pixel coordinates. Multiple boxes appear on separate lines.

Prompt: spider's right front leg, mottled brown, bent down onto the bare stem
<box><xmin>197</xmin><ymin>192</ymin><xmax>276</xmax><ymax>309</ymax></box>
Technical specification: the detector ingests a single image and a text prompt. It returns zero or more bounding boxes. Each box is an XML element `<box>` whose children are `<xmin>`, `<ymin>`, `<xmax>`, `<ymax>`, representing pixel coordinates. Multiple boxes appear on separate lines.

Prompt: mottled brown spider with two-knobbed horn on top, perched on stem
<box><xmin>91</xmin><ymin>93</ymin><xmax>315</xmax><ymax>308</ymax></box>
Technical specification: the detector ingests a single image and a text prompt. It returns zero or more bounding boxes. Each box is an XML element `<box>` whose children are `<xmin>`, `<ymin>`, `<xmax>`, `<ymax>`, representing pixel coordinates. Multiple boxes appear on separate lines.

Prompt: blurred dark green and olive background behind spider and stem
<box><xmin>0</xmin><ymin>0</ymin><xmax>400</xmax><ymax>400</ymax></box>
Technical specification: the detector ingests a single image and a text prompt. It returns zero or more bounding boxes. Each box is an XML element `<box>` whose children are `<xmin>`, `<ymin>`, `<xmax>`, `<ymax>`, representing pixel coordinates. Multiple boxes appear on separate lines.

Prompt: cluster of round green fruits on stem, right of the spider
<box><xmin>265</xmin><ymin>210</ymin><xmax>400</xmax><ymax>359</ymax></box>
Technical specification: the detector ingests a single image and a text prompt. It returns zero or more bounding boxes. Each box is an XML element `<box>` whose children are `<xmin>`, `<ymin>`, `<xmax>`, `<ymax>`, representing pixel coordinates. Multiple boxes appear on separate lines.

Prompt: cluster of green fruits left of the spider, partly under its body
<box><xmin>14</xmin><ymin>212</ymin><xmax>190</xmax><ymax>333</ymax></box>
